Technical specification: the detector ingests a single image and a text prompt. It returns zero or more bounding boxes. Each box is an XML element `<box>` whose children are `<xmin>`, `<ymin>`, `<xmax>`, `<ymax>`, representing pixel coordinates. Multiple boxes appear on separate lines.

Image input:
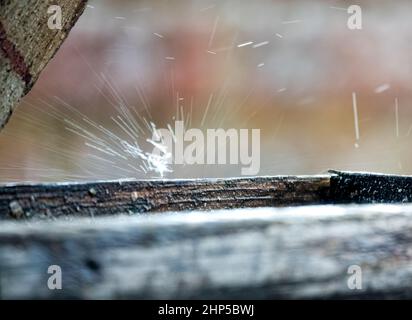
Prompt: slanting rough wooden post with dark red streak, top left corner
<box><xmin>0</xmin><ymin>0</ymin><xmax>87</xmax><ymax>130</ymax></box>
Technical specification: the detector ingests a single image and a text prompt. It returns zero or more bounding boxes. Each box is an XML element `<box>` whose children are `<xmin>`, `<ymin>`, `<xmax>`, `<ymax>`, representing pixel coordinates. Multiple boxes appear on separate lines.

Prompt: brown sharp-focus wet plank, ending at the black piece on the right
<box><xmin>0</xmin><ymin>175</ymin><xmax>330</xmax><ymax>220</ymax></box>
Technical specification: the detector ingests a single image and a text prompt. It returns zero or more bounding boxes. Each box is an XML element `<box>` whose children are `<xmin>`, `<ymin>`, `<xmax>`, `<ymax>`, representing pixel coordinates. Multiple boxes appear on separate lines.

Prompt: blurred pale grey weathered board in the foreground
<box><xmin>0</xmin><ymin>205</ymin><xmax>412</xmax><ymax>299</ymax></box>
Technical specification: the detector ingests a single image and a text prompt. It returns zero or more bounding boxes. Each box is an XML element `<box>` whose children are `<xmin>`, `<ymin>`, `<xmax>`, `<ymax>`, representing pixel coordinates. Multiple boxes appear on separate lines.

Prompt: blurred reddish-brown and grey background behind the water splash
<box><xmin>0</xmin><ymin>0</ymin><xmax>412</xmax><ymax>182</ymax></box>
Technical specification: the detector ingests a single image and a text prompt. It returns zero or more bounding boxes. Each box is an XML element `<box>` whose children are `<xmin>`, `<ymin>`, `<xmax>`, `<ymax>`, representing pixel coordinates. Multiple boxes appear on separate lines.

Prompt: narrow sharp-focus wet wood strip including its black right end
<box><xmin>0</xmin><ymin>171</ymin><xmax>412</xmax><ymax>220</ymax></box>
